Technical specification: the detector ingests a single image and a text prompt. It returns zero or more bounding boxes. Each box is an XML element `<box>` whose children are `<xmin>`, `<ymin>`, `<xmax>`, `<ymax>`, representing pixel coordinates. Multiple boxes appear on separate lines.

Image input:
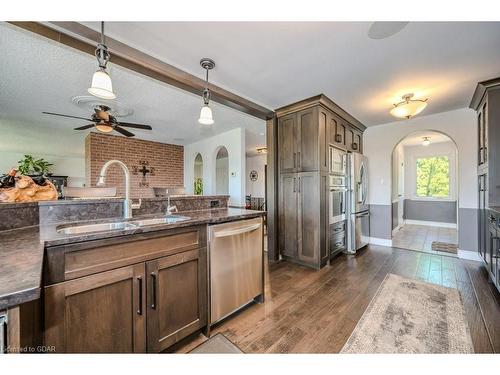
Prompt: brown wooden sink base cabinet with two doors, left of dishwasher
<box><xmin>44</xmin><ymin>226</ymin><xmax>208</xmax><ymax>353</ymax></box>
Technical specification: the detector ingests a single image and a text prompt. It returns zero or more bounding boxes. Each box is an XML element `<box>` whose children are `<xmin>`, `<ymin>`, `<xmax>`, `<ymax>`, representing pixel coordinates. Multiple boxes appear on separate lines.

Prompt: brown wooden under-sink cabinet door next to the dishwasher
<box><xmin>146</xmin><ymin>248</ymin><xmax>207</xmax><ymax>353</ymax></box>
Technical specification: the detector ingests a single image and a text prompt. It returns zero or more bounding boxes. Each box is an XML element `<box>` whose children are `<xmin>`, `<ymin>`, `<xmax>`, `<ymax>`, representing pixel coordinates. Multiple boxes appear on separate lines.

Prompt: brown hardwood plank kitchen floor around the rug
<box><xmin>170</xmin><ymin>246</ymin><xmax>500</xmax><ymax>353</ymax></box>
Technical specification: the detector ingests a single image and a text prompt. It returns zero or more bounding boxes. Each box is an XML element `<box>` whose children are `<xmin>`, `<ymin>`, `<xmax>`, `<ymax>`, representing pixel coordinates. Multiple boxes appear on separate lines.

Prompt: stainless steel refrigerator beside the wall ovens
<box><xmin>347</xmin><ymin>153</ymin><xmax>370</xmax><ymax>254</ymax></box>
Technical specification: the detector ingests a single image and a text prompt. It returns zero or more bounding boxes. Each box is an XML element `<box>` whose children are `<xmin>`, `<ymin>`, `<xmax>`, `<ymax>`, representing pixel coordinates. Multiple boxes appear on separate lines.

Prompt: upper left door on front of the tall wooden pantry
<box><xmin>278</xmin><ymin>113</ymin><xmax>299</xmax><ymax>173</ymax></box>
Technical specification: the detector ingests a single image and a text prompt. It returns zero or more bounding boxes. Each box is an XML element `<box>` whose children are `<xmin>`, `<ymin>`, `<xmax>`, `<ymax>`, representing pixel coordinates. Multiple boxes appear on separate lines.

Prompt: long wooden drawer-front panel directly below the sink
<box><xmin>45</xmin><ymin>227</ymin><xmax>206</xmax><ymax>284</ymax></box>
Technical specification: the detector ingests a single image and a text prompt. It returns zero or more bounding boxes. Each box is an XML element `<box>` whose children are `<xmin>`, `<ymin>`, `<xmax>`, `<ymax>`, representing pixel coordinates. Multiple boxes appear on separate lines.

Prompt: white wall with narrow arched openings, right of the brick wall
<box><xmin>184</xmin><ymin>128</ymin><xmax>245</xmax><ymax>206</ymax></box>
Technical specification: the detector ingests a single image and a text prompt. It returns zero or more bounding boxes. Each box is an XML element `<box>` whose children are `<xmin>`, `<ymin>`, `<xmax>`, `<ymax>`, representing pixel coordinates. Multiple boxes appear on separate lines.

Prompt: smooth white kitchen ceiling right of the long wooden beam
<box><xmin>77</xmin><ymin>22</ymin><xmax>500</xmax><ymax>126</ymax></box>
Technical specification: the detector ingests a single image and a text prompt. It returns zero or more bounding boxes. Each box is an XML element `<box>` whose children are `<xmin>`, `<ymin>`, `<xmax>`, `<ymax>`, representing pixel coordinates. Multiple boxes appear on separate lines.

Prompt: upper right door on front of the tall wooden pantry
<box><xmin>297</xmin><ymin>108</ymin><xmax>319</xmax><ymax>172</ymax></box>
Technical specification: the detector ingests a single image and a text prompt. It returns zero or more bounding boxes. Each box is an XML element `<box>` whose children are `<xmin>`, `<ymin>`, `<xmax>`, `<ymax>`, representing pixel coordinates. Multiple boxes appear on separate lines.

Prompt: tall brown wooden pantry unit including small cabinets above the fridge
<box><xmin>276</xmin><ymin>95</ymin><xmax>365</xmax><ymax>268</ymax></box>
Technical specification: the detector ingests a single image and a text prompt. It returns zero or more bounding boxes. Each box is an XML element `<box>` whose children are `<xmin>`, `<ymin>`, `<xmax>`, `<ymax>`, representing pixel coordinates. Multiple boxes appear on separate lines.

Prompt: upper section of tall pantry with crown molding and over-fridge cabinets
<box><xmin>276</xmin><ymin>95</ymin><xmax>365</xmax><ymax>173</ymax></box>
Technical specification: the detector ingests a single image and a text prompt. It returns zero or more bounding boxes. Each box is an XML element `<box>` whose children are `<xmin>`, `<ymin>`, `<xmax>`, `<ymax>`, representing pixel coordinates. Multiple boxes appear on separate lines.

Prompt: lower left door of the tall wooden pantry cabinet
<box><xmin>278</xmin><ymin>174</ymin><xmax>298</xmax><ymax>257</ymax></box>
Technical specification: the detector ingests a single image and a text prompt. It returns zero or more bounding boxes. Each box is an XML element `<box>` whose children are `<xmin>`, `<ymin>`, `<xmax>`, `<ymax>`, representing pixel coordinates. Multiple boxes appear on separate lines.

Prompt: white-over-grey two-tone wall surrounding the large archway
<box><xmin>364</xmin><ymin>108</ymin><xmax>477</xmax><ymax>251</ymax></box>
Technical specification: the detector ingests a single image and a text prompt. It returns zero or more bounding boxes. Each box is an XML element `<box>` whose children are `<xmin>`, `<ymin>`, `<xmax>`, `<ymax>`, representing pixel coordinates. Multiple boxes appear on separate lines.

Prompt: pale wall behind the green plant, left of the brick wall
<box><xmin>0</xmin><ymin>118</ymin><xmax>86</xmax><ymax>186</ymax></box>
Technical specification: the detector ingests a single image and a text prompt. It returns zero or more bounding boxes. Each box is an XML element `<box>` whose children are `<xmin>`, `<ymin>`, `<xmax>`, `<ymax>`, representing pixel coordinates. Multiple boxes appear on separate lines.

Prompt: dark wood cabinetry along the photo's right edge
<box><xmin>470</xmin><ymin>78</ymin><xmax>500</xmax><ymax>290</ymax></box>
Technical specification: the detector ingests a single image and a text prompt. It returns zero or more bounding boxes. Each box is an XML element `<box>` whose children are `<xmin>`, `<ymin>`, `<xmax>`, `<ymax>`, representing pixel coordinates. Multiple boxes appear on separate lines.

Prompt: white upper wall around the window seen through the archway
<box><xmin>404</xmin><ymin>141</ymin><xmax>457</xmax><ymax>201</ymax></box>
